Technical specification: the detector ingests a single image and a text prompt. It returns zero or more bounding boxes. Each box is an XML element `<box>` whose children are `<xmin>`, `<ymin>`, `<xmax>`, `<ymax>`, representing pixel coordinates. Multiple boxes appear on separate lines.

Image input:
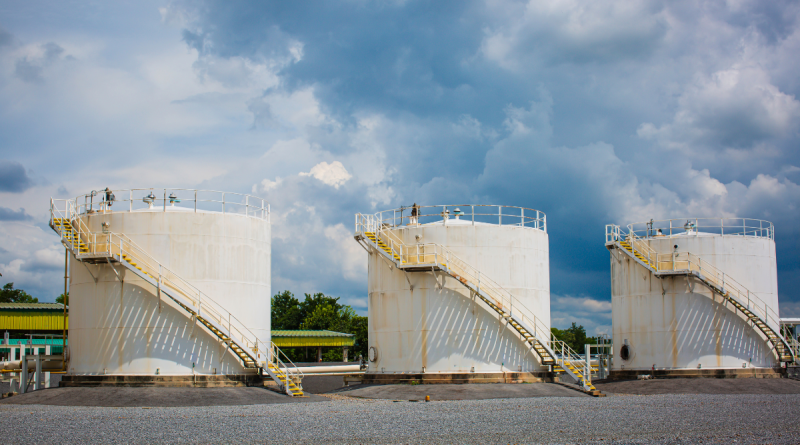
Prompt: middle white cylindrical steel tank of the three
<box><xmin>368</xmin><ymin>205</ymin><xmax>550</xmax><ymax>374</ymax></box>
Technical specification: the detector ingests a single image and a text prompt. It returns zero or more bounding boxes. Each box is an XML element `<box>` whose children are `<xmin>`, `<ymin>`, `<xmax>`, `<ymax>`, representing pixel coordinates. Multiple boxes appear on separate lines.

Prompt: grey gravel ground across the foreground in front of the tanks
<box><xmin>0</xmin><ymin>394</ymin><xmax>800</xmax><ymax>444</ymax></box>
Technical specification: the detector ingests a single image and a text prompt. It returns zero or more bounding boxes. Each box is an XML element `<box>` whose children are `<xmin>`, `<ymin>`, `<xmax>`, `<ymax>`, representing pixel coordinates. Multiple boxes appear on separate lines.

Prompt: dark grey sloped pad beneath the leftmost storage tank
<box><xmin>0</xmin><ymin>387</ymin><xmax>329</xmax><ymax>407</ymax></box>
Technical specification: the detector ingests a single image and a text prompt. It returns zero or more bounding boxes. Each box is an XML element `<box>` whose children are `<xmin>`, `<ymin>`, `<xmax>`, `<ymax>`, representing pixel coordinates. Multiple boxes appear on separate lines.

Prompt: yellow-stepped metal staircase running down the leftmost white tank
<box><xmin>50</xmin><ymin>200</ymin><xmax>305</xmax><ymax>397</ymax></box>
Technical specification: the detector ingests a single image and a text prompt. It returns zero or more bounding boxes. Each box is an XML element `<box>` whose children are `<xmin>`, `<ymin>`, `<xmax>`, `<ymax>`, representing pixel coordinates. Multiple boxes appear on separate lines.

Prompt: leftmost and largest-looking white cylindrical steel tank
<box><xmin>69</xmin><ymin>189</ymin><xmax>271</xmax><ymax>375</ymax></box>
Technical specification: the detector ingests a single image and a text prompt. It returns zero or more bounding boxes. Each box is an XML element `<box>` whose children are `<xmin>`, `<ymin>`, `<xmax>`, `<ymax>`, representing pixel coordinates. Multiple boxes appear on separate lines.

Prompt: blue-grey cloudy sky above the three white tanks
<box><xmin>0</xmin><ymin>0</ymin><xmax>800</xmax><ymax>331</ymax></box>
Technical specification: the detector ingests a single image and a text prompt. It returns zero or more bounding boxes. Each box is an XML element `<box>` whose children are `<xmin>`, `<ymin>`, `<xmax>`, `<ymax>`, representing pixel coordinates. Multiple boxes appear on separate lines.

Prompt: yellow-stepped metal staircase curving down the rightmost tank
<box><xmin>606</xmin><ymin>225</ymin><xmax>796</xmax><ymax>363</ymax></box>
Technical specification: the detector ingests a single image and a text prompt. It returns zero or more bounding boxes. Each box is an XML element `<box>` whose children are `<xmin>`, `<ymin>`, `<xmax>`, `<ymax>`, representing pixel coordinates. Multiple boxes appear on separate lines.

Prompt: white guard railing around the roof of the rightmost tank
<box><xmin>628</xmin><ymin>218</ymin><xmax>775</xmax><ymax>241</ymax></box>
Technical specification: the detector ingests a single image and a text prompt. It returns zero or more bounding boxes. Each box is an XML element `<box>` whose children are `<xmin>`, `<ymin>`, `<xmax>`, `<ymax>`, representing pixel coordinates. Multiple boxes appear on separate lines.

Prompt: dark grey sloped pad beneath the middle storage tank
<box><xmin>328</xmin><ymin>383</ymin><xmax>590</xmax><ymax>400</ymax></box>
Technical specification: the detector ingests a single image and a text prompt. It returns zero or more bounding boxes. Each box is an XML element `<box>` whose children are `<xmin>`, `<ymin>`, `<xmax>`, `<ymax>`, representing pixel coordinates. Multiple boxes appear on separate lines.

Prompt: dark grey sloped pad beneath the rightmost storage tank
<box><xmin>594</xmin><ymin>378</ymin><xmax>800</xmax><ymax>395</ymax></box>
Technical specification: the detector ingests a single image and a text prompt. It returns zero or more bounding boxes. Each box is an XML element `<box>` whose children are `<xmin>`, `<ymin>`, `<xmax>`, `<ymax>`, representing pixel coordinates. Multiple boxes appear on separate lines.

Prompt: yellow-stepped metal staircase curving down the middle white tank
<box><xmin>354</xmin><ymin>213</ymin><xmax>600</xmax><ymax>395</ymax></box>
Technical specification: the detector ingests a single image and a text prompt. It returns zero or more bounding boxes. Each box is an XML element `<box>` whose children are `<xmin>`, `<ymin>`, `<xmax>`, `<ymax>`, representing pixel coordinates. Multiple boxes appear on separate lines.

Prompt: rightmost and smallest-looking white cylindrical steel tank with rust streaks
<box><xmin>611</xmin><ymin>218</ymin><xmax>779</xmax><ymax>371</ymax></box>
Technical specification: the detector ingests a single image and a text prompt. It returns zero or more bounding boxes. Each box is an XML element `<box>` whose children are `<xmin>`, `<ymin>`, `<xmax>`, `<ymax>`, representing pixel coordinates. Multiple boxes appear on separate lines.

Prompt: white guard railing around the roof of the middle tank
<box><xmin>375</xmin><ymin>204</ymin><xmax>547</xmax><ymax>233</ymax></box>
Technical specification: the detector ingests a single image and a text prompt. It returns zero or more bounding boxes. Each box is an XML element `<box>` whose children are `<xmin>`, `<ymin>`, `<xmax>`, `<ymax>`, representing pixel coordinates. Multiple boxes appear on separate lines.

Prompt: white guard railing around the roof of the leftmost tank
<box><xmin>52</xmin><ymin>188</ymin><xmax>270</xmax><ymax>221</ymax></box>
